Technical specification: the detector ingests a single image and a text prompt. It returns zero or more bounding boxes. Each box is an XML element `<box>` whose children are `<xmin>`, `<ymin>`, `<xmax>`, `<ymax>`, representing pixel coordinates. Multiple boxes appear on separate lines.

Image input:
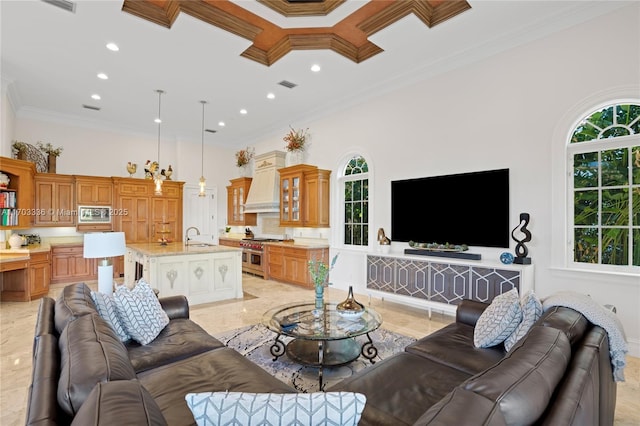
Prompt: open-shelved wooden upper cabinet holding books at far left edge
<box><xmin>0</xmin><ymin>157</ymin><xmax>36</xmax><ymax>229</ymax></box>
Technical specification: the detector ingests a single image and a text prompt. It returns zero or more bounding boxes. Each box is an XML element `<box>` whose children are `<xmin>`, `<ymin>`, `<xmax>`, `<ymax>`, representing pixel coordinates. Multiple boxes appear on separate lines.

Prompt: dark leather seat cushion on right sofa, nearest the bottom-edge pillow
<box><xmin>327</xmin><ymin>352</ymin><xmax>470</xmax><ymax>426</ymax></box>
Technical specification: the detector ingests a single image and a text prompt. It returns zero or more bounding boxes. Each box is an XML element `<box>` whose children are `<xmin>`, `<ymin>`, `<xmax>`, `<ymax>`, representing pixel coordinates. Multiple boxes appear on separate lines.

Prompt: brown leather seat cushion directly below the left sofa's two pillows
<box><xmin>125</xmin><ymin>319</ymin><xmax>224</xmax><ymax>373</ymax></box>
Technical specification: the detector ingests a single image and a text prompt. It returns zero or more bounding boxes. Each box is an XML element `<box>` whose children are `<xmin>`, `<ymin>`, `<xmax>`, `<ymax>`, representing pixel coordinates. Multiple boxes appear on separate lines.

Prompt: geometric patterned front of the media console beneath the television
<box><xmin>367</xmin><ymin>255</ymin><xmax>533</xmax><ymax>314</ymax></box>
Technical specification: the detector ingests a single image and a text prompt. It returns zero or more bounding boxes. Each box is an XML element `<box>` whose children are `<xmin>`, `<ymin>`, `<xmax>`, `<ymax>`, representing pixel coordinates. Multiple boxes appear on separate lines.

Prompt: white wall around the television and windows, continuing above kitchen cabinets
<box><xmin>2</xmin><ymin>2</ymin><xmax>640</xmax><ymax>356</ymax></box>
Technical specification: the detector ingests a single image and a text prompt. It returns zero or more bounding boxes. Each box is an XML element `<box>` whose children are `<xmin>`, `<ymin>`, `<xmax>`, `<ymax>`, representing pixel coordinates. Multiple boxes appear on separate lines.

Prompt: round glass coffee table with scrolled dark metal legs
<box><xmin>262</xmin><ymin>302</ymin><xmax>382</xmax><ymax>389</ymax></box>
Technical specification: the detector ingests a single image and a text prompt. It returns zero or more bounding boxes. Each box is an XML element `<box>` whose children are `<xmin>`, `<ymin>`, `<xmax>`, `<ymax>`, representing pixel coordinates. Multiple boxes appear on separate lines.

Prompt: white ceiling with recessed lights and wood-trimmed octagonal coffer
<box><xmin>0</xmin><ymin>0</ymin><xmax>625</xmax><ymax>147</ymax></box>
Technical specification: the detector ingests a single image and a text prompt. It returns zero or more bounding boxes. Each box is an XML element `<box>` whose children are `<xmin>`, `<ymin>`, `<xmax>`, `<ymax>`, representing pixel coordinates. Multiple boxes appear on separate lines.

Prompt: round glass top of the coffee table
<box><xmin>262</xmin><ymin>302</ymin><xmax>382</xmax><ymax>340</ymax></box>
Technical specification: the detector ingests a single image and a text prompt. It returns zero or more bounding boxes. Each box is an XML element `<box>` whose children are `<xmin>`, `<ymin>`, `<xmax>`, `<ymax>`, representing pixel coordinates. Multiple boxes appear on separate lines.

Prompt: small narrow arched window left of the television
<box><xmin>342</xmin><ymin>155</ymin><xmax>369</xmax><ymax>246</ymax></box>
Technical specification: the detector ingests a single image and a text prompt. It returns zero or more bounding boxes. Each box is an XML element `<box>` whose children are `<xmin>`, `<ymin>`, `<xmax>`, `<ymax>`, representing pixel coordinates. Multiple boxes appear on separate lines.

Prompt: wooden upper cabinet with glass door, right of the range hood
<box><xmin>279</xmin><ymin>164</ymin><xmax>331</xmax><ymax>228</ymax></box>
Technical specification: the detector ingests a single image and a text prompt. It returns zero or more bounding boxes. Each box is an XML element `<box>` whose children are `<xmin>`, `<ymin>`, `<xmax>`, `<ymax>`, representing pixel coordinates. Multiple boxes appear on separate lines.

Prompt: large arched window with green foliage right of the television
<box><xmin>567</xmin><ymin>103</ymin><xmax>640</xmax><ymax>270</ymax></box>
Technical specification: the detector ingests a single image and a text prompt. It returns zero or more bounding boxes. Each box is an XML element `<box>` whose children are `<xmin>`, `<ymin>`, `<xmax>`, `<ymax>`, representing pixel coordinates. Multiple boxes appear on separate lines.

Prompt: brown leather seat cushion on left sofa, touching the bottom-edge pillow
<box><xmin>138</xmin><ymin>347</ymin><xmax>296</xmax><ymax>426</ymax></box>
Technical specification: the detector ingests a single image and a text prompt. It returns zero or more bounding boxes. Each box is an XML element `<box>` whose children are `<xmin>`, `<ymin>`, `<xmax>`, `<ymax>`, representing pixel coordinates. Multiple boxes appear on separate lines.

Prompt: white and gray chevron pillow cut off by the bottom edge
<box><xmin>185</xmin><ymin>392</ymin><xmax>367</xmax><ymax>426</ymax></box>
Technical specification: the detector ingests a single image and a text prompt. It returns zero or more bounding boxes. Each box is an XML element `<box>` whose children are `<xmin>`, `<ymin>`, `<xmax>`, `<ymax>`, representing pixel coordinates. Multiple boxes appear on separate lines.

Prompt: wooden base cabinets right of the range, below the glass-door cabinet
<box><xmin>265</xmin><ymin>244</ymin><xmax>329</xmax><ymax>287</ymax></box>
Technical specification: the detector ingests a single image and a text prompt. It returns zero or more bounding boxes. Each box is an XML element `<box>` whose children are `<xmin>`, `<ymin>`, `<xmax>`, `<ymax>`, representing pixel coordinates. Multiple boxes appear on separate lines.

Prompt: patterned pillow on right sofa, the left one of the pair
<box><xmin>473</xmin><ymin>288</ymin><xmax>522</xmax><ymax>348</ymax></box>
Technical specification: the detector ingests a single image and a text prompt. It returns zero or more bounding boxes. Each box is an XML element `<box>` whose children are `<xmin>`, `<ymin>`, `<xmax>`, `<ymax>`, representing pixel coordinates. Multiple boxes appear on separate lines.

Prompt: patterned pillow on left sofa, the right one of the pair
<box><xmin>114</xmin><ymin>279</ymin><xmax>169</xmax><ymax>345</ymax></box>
